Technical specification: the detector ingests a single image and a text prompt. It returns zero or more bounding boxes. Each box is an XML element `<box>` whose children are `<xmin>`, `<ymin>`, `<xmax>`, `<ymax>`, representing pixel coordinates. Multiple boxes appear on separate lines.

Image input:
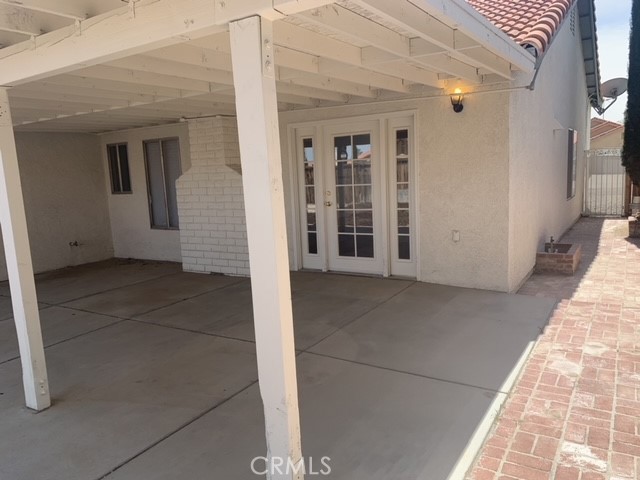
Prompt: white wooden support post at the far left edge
<box><xmin>0</xmin><ymin>87</ymin><xmax>51</xmax><ymax>411</ymax></box>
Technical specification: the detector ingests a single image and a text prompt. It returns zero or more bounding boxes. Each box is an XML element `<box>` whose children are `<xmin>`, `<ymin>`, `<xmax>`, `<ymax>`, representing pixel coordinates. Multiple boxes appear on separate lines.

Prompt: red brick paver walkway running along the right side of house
<box><xmin>467</xmin><ymin>218</ymin><xmax>640</xmax><ymax>480</ymax></box>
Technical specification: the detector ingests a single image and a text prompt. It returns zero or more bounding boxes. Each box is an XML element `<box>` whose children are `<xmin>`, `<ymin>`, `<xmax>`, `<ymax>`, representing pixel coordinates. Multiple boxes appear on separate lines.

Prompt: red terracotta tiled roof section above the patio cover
<box><xmin>467</xmin><ymin>0</ymin><xmax>576</xmax><ymax>54</ymax></box>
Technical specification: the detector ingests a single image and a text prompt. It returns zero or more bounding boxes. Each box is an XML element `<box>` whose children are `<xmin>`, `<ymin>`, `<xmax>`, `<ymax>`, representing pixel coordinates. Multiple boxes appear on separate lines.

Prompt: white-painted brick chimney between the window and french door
<box><xmin>176</xmin><ymin>117</ymin><xmax>249</xmax><ymax>276</ymax></box>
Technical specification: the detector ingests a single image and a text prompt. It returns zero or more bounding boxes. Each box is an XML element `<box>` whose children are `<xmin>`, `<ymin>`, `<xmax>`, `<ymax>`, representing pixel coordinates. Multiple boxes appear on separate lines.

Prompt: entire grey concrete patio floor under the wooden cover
<box><xmin>0</xmin><ymin>262</ymin><xmax>553</xmax><ymax>480</ymax></box>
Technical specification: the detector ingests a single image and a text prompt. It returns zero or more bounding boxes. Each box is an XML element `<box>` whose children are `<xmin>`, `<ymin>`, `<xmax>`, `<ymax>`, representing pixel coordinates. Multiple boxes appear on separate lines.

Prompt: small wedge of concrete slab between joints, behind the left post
<box><xmin>0</xmin><ymin>307</ymin><xmax>119</xmax><ymax>363</ymax></box>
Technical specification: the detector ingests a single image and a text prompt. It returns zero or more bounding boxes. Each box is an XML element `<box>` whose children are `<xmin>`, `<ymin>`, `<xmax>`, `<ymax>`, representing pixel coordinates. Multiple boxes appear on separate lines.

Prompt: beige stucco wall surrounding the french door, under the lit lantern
<box><xmin>280</xmin><ymin>93</ymin><xmax>509</xmax><ymax>290</ymax></box>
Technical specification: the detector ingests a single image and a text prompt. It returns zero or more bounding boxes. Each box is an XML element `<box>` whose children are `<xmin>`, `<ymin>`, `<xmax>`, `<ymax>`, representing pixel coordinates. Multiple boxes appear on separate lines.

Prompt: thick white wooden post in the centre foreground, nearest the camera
<box><xmin>229</xmin><ymin>16</ymin><xmax>303</xmax><ymax>480</ymax></box>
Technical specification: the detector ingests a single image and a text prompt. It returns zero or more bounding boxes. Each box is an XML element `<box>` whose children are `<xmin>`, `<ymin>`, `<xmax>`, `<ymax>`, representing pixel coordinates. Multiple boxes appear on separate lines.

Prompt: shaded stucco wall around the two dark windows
<box><xmin>100</xmin><ymin>123</ymin><xmax>191</xmax><ymax>262</ymax></box>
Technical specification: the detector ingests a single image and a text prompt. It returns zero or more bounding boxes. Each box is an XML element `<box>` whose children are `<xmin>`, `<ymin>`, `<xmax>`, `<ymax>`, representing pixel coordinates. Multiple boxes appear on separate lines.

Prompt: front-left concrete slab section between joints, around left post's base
<box><xmin>0</xmin><ymin>321</ymin><xmax>257</xmax><ymax>480</ymax></box>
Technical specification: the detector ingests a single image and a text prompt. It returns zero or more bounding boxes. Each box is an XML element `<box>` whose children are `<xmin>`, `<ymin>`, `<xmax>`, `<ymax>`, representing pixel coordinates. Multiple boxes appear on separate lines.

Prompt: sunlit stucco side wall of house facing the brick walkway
<box><xmin>509</xmin><ymin>15</ymin><xmax>590</xmax><ymax>290</ymax></box>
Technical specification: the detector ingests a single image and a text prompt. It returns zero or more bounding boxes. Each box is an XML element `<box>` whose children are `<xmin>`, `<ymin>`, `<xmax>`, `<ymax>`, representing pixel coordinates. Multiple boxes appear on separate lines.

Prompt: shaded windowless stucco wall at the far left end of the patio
<box><xmin>0</xmin><ymin>132</ymin><xmax>113</xmax><ymax>280</ymax></box>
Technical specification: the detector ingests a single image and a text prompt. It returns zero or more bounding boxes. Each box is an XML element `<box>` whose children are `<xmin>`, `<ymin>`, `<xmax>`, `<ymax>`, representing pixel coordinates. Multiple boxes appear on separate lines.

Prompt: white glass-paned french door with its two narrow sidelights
<box><xmin>295</xmin><ymin>117</ymin><xmax>416</xmax><ymax>277</ymax></box>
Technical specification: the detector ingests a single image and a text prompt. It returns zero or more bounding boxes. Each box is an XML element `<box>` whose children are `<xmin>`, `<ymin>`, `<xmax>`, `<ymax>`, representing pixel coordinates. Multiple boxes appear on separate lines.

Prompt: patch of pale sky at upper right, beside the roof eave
<box><xmin>593</xmin><ymin>0</ymin><xmax>632</xmax><ymax>122</ymax></box>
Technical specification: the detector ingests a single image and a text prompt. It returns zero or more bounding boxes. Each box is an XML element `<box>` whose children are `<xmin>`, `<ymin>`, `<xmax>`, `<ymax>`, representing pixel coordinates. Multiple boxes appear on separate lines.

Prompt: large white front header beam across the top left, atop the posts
<box><xmin>0</xmin><ymin>0</ymin><xmax>340</xmax><ymax>86</ymax></box>
